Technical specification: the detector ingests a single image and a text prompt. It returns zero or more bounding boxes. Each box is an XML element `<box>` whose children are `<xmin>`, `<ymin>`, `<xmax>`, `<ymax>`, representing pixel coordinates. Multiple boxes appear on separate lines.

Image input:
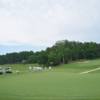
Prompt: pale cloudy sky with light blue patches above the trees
<box><xmin>0</xmin><ymin>0</ymin><xmax>100</xmax><ymax>54</ymax></box>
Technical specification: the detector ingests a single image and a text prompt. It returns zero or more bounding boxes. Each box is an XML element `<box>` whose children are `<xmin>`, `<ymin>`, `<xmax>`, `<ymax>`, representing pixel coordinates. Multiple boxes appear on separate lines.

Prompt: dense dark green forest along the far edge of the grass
<box><xmin>0</xmin><ymin>40</ymin><xmax>100</xmax><ymax>66</ymax></box>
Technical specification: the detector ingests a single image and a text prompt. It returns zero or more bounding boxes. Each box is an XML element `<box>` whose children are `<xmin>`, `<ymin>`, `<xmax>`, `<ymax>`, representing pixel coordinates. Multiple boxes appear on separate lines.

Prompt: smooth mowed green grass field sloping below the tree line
<box><xmin>0</xmin><ymin>59</ymin><xmax>100</xmax><ymax>100</ymax></box>
